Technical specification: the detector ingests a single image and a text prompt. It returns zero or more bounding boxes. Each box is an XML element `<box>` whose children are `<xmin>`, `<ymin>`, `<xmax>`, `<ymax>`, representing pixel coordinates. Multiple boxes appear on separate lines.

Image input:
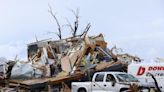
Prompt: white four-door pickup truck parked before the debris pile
<box><xmin>72</xmin><ymin>72</ymin><xmax>139</xmax><ymax>92</ymax></box>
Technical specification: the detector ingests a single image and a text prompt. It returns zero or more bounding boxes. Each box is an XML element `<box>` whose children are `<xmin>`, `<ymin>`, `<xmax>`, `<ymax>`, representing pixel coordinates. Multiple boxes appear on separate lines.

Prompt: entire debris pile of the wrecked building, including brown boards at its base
<box><xmin>0</xmin><ymin>34</ymin><xmax>141</xmax><ymax>89</ymax></box>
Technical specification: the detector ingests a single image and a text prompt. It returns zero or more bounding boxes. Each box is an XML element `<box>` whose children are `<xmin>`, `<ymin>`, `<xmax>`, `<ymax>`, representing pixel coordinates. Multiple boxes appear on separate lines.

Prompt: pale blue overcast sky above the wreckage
<box><xmin>0</xmin><ymin>0</ymin><xmax>164</xmax><ymax>62</ymax></box>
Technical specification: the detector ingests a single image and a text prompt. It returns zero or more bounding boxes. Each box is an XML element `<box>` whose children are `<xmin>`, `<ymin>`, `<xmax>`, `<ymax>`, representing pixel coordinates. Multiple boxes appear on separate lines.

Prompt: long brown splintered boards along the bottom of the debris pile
<box><xmin>9</xmin><ymin>73</ymin><xmax>84</xmax><ymax>89</ymax></box>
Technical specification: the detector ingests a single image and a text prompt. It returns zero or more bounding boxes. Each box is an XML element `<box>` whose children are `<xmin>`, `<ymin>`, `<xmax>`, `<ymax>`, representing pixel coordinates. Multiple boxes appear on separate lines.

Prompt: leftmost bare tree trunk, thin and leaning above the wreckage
<box><xmin>48</xmin><ymin>5</ymin><xmax>62</xmax><ymax>40</ymax></box>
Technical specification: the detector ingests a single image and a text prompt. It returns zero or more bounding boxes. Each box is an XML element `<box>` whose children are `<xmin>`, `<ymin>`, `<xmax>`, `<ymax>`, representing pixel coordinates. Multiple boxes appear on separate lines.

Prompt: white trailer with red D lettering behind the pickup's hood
<box><xmin>128</xmin><ymin>62</ymin><xmax>164</xmax><ymax>92</ymax></box>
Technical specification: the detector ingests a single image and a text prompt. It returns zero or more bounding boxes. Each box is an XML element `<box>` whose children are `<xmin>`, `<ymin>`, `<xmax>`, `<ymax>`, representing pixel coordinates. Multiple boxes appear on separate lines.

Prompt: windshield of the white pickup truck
<box><xmin>116</xmin><ymin>74</ymin><xmax>138</xmax><ymax>82</ymax></box>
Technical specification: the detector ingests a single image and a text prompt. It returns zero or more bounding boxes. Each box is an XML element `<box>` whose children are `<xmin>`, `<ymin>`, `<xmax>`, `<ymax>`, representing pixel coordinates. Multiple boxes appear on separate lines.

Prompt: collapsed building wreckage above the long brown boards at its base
<box><xmin>11</xmin><ymin>34</ymin><xmax>140</xmax><ymax>78</ymax></box>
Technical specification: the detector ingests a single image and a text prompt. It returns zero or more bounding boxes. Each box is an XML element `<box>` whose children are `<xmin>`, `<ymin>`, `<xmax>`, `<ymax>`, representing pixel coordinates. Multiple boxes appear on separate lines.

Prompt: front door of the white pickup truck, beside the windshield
<box><xmin>103</xmin><ymin>74</ymin><xmax>119</xmax><ymax>92</ymax></box>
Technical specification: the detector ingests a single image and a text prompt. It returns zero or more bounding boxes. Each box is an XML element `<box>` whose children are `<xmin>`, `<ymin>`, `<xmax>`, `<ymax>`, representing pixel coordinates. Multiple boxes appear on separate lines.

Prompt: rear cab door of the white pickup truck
<box><xmin>91</xmin><ymin>74</ymin><xmax>107</xmax><ymax>92</ymax></box>
